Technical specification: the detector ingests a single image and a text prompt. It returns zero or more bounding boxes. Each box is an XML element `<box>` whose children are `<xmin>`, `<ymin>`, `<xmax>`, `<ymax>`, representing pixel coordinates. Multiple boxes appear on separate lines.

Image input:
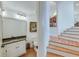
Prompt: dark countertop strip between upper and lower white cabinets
<box><xmin>2</xmin><ymin>36</ymin><xmax>26</xmax><ymax>45</ymax></box>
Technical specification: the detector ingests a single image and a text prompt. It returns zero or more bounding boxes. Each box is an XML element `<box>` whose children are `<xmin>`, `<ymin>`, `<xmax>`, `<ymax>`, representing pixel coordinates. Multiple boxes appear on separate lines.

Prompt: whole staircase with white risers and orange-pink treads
<box><xmin>48</xmin><ymin>27</ymin><xmax>79</xmax><ymax>57</ymax></box>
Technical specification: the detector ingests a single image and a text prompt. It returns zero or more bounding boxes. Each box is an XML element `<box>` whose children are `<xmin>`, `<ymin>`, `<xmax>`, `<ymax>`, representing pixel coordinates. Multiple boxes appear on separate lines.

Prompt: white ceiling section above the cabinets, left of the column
<box><xmin>2</xmin><ymin>1</ymin><xmax>39</xmax><ymax>14</ymax></box>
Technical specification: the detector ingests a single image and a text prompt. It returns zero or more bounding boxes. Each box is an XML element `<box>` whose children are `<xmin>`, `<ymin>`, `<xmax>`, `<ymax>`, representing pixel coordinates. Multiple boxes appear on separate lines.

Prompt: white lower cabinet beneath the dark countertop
<box><xmin>4</xmin><ymin>40</ymin><xmax>26</xmax><ymax>57</ymax></box>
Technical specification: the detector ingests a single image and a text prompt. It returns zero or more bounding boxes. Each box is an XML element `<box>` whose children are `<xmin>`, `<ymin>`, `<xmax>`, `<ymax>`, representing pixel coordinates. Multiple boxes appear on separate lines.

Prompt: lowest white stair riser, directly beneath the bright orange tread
<box><xmin>47</xmin><ymin>48</ymin><xmax>78</xmax><ymax>57</ymax></box>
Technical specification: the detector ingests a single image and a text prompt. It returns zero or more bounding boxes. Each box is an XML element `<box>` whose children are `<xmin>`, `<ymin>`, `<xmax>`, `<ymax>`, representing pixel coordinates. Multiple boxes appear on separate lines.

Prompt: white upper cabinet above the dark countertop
<box><xmin>3</xmin><ymin>18</ymin><xmax>27</xmax><ymax>38</ymax></box>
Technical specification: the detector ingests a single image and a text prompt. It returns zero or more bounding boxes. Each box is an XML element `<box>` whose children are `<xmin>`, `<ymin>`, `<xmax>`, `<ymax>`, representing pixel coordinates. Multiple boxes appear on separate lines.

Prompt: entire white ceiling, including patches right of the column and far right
<box><xmin>2</xmin><ymin>1</ymin><xmax>79</xmax><ymax>14</ymax></box>
